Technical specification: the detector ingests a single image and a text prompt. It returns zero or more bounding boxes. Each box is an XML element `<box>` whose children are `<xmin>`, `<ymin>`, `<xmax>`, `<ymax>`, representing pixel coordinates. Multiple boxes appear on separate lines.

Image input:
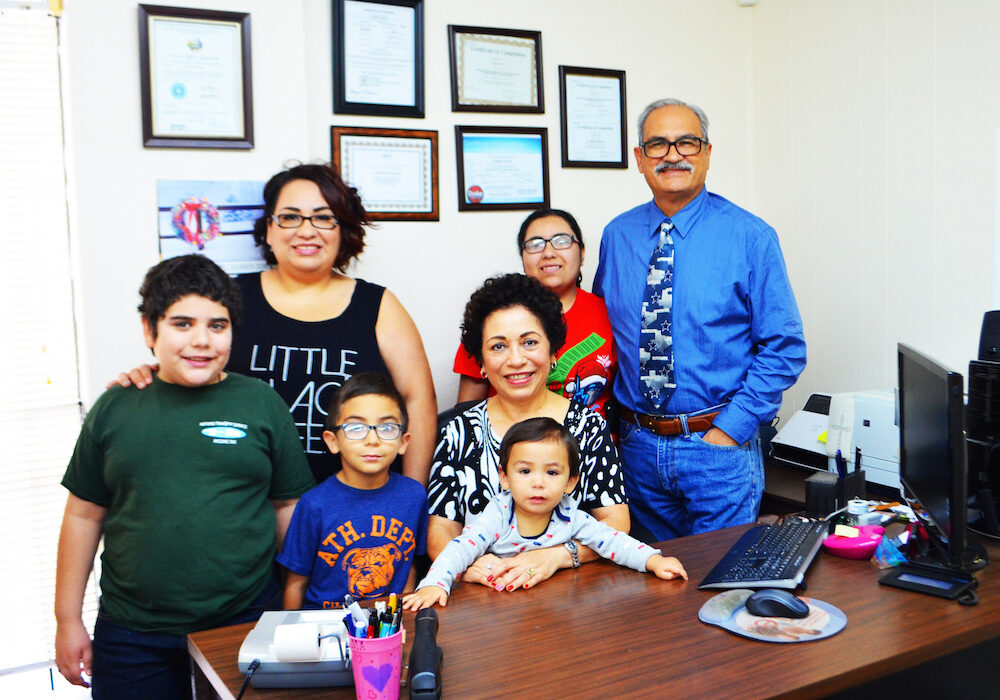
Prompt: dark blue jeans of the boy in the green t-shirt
<box><xmin>91</xmin><ymin>576</ymin><xmax>281</xmax><ymax>700</ymax></box>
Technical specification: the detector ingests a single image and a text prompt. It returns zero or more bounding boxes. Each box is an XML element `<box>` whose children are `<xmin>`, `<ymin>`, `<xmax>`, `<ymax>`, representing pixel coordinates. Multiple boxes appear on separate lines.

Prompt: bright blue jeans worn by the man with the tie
<box><xmin>618</xmin><ymin>420</ymin><xmax>764</xmax><ymax>542</ymax></box>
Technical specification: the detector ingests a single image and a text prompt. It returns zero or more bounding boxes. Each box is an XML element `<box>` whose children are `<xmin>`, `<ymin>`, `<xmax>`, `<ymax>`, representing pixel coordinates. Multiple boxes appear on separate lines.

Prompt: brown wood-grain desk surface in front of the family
<box><xmin>188</xmin><ymin>528</ymin><xmax>1000</xmax><ymax>698</ymax></box>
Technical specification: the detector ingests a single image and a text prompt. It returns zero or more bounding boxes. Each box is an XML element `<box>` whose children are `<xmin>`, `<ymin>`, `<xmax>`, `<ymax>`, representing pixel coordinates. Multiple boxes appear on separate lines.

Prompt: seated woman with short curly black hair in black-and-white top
<box><xmin>427</xmin><ymin>274</ymin><xmax>629</xmax><ymax>590</ymax></box>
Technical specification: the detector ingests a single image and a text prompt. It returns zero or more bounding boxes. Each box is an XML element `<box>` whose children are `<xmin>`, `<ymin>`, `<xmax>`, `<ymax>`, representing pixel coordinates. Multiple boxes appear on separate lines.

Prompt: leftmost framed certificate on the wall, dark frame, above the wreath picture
<box><xmin>139</xmin><ymin>5</ymin><xmax>253</xmax><ymax>149</ymax></box>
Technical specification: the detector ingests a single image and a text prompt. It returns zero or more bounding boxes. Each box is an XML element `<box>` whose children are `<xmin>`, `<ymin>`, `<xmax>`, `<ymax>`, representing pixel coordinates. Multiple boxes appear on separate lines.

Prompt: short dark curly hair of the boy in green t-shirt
<box><xmin>139</xmin><ymin>253</ymin><xmax>243</xmax><ymax>340</ymax></box>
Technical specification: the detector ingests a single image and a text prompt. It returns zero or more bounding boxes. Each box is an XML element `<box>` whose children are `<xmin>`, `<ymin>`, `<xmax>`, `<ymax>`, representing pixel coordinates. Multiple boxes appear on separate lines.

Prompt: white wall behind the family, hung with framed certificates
<box><xmin>66</xmin><ymin>0</ymin><xmax>751</xmax><ymax>406</ymax></box>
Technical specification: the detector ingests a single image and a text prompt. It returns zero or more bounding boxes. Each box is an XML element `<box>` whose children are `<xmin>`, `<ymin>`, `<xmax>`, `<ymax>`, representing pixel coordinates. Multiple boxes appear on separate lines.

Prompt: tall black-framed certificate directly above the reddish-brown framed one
<box><xmin>333</xmin><ymin>0</ymin><xmax>424</xmax><ymax>117</ymax></box>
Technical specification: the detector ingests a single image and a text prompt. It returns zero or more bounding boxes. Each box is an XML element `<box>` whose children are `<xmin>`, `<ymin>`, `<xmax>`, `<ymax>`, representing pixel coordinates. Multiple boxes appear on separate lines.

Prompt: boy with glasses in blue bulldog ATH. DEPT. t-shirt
<box><xmin>278</xmin><ymin>372</ymin><xmax>427</xmax><ymax>610</ymax></box>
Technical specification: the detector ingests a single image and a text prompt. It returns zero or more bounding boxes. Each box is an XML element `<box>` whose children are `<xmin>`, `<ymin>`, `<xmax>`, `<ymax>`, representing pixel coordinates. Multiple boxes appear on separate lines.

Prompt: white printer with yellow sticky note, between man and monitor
<box><xmin>771</xmin><ymin>390</ymin><xmax>899</xmax><ymax>489</ymax></box>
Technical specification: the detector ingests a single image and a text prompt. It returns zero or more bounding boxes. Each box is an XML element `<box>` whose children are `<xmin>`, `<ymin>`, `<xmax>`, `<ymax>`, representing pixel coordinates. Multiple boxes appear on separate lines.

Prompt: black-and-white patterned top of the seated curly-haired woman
<box><xmin>427</xmin><ymin>401</ymin><xmax>627</xmax><ymax>524</ymax></box>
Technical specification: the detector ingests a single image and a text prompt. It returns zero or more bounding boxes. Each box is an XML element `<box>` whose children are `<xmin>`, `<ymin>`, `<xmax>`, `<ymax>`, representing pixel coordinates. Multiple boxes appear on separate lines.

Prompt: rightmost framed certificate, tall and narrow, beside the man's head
<box><xmin>559</xmin><ymin>66</ymin><xmax>628</xmax><ymax>168</ymax></box>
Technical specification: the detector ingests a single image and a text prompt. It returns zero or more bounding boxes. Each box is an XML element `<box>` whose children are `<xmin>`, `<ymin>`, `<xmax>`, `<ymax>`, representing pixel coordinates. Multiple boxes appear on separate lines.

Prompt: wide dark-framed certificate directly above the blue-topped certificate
<box><xmin>448</xmin><ymin>24</ymin><xmax>545</xmax><ymax>114</ymax></box>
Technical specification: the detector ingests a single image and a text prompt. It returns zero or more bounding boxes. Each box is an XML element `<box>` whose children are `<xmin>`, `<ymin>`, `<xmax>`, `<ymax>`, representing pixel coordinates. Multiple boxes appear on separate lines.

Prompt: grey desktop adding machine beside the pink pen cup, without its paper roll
<box><xmin>237</xmin><ymin>610</ymin><xmax>354</xmax><ymax>688</ymax></box>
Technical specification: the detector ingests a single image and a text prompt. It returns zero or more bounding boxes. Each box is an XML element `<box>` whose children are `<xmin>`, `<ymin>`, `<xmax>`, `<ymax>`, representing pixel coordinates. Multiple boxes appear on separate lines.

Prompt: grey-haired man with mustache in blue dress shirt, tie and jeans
<box><xmin>594</xmin><ymin>99</ymin><xmax>806</xmax><ymax>541</ymax></box>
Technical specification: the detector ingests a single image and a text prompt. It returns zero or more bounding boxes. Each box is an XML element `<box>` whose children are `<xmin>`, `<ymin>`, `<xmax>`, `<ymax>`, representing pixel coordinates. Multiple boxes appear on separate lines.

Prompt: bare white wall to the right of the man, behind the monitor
<box><xmin>751</xmin><ymin>0</ymin><xmax>1000</xmax><ymax>418</ymax></box>
